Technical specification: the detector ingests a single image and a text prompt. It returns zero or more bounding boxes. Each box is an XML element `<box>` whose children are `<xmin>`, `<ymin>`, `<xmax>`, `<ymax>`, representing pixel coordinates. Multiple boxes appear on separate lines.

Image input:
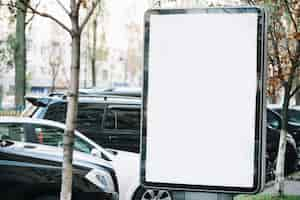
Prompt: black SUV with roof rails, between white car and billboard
<box><xmin>23</xmin><ymin>95</ymin><xmax>141</xmax><ymax>152</ymax></box>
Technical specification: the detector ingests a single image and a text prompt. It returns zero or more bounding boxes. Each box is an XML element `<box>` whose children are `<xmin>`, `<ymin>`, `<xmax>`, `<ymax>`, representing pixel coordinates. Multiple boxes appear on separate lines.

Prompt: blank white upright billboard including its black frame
<box><xmin>141</xmin><ymin>7</ymin><xmax>266</xmax><ymax>193</ymax></box>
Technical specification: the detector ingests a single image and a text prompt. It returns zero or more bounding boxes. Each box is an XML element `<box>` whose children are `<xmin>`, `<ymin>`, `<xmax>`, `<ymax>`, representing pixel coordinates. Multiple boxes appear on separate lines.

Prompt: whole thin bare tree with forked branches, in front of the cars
<box><xmin>2</xmin><ymin>0</ymin><xmax>100</xmax><ymax>200</ymax></box>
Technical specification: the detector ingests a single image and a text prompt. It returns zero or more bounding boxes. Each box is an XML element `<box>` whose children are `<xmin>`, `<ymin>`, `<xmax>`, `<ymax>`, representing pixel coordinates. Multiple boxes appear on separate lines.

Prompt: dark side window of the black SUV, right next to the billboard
<box><xmin>104</xmin><ymin>108</ymin><xmax>140</xmax><ymax>130</ymax></box>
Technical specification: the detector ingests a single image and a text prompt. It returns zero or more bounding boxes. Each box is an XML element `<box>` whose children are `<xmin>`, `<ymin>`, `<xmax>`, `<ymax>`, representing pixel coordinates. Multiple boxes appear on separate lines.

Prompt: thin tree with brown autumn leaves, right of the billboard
<box><xmin>249</xmin><ymin>0</ymin><xmax>300</xmax><ymax>196</ymax></box>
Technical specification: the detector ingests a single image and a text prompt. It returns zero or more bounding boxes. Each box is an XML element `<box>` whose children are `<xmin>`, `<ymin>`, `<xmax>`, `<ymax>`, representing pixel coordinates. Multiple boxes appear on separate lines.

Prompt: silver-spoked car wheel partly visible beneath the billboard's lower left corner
<box><xmin>134</xmin><ymin>188</ymin><xmax>173</xmax><ymax>200</ymax></box>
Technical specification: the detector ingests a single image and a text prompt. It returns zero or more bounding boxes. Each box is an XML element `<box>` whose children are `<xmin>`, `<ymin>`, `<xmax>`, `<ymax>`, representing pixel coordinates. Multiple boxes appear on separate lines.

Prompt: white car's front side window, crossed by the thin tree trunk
<box><xmin>34</xmin><ymin>125</ymin><xmax>93</xmax><ymax>153</ymax></box>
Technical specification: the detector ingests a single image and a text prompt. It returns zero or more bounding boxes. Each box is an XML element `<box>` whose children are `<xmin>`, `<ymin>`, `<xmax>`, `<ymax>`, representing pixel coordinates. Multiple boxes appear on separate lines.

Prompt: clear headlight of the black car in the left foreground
<box><xmin>85</xmin><ymin>169</ymin><xmax>116</xmax><ymax>193</ymax></box>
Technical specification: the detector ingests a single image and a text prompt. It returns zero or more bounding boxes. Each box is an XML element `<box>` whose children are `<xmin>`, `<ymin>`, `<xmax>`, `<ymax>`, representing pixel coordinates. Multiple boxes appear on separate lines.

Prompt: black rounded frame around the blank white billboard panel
<box><xmin>140</xmin><ymin>7</ymin><xmax>267</xmax><ymax>194</ymax></box>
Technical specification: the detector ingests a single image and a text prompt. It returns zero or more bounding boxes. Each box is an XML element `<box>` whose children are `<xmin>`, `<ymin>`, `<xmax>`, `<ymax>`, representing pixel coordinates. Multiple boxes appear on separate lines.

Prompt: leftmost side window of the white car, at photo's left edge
<box><xmin>0</xmin><ymin>123</ymin><xmax>25</xmax><ymax>142</ymax></box>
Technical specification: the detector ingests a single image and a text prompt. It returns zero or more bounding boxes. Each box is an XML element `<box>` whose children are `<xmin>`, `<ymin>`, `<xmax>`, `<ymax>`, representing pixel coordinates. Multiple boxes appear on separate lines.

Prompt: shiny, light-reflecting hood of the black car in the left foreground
<box><xmin>1</xmin><ymin>141</ymin><xmax>112</xmax><ymax>169</ymax></box>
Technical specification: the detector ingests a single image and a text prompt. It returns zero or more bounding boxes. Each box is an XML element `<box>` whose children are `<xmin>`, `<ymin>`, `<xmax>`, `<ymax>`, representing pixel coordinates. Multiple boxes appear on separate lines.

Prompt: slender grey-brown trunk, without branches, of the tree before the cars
<box><xmin>60</xmin><ymin>25</ymin><xmax>80</xmax><ymax>200</ymax></box>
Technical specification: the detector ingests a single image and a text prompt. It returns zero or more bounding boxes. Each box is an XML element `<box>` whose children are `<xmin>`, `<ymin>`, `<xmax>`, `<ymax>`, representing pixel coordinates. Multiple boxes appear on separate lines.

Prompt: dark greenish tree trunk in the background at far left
<box><xmin>14</xmin><ymin>0</ymin><xmax>26</xmax><ymax>109</ymax></box>
